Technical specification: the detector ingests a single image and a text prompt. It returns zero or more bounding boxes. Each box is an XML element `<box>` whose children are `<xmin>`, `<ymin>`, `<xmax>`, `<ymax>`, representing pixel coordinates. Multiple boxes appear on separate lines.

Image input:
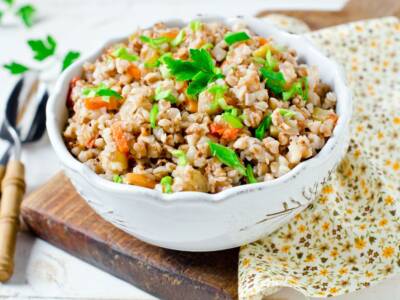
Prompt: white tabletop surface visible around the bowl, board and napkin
<box><xmin>0</xmin><ymin>0</ymin><xmax>400</xmax><ymax>300</ymax></box>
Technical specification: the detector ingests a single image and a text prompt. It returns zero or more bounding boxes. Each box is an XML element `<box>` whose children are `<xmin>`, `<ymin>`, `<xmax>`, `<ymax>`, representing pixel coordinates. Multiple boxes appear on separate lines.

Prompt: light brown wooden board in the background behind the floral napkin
<box><xmin>258</xmin><ymin>0</ymin><xmax>400</xmax><ymax>30</ymax></box>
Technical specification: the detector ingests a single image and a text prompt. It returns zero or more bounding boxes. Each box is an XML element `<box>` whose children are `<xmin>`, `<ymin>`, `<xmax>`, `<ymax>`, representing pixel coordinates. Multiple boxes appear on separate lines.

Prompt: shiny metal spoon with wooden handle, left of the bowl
<box><xmin>0</xmin><ymin>73</ymin><xmax>48</xmax><ymax>282</ymax></box>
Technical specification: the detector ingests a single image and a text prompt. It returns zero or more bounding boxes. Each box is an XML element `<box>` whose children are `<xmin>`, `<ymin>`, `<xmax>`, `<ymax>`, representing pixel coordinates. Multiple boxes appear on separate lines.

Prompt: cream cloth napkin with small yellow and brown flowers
<box><xmin>239</xmin><ymin>17</ymin><xmax>400</xmax><ymax>299</ymax></box>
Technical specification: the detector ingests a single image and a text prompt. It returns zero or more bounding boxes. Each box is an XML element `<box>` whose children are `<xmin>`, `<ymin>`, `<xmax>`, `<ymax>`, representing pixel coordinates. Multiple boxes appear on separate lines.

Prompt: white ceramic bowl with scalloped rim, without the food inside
<box><xmin>47</xmin><ymin>17</ymin><xmax>351</xmax><ymax>251</ymax></box>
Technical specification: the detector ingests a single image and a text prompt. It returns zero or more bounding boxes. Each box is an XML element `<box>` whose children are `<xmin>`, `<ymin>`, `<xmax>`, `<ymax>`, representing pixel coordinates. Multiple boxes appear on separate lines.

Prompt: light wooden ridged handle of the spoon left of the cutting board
<box><xmin>0</xmin><ymin>160</ymin><xmax>25</xmax><ymax>282</ymax></box>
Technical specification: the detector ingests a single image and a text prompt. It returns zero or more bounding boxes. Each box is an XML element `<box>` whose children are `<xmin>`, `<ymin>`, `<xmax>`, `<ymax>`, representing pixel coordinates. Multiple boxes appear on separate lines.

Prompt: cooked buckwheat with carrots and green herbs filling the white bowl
<box><xmin>63</xmin><ymin>21</ymin><xmax>338</xmax><ymax>193</ymax></box>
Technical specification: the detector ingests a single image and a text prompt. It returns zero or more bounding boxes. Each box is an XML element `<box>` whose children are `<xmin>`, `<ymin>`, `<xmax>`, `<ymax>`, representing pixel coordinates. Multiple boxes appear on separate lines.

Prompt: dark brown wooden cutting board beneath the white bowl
<box><xmin>22</xmin><ymin>173</ymin><xmax>238</xmax><ymax>299</ymax></box>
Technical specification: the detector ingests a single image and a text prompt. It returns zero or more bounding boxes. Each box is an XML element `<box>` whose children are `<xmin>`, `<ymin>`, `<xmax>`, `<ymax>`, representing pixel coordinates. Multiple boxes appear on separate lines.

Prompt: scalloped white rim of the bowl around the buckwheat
<box><xmin>46</xmin><ymin>16</ymin><xmax>352</xmax><ymax>204</ymax></box>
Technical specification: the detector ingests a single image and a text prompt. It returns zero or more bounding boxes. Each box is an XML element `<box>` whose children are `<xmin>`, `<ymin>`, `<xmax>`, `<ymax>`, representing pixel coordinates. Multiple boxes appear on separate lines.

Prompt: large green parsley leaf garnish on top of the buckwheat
<box><xmin>163</xmin><ymin>49</ymin><xmax>223</xmax><ymax>96</ymax></box>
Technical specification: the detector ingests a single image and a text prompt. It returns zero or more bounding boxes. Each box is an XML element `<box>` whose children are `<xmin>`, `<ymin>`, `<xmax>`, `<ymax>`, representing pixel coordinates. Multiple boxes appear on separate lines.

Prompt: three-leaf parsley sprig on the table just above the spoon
<box><xmin>4</xmin><ymin>35</ymin><xmax>80</xmax><ymax>75</ymax></box>
